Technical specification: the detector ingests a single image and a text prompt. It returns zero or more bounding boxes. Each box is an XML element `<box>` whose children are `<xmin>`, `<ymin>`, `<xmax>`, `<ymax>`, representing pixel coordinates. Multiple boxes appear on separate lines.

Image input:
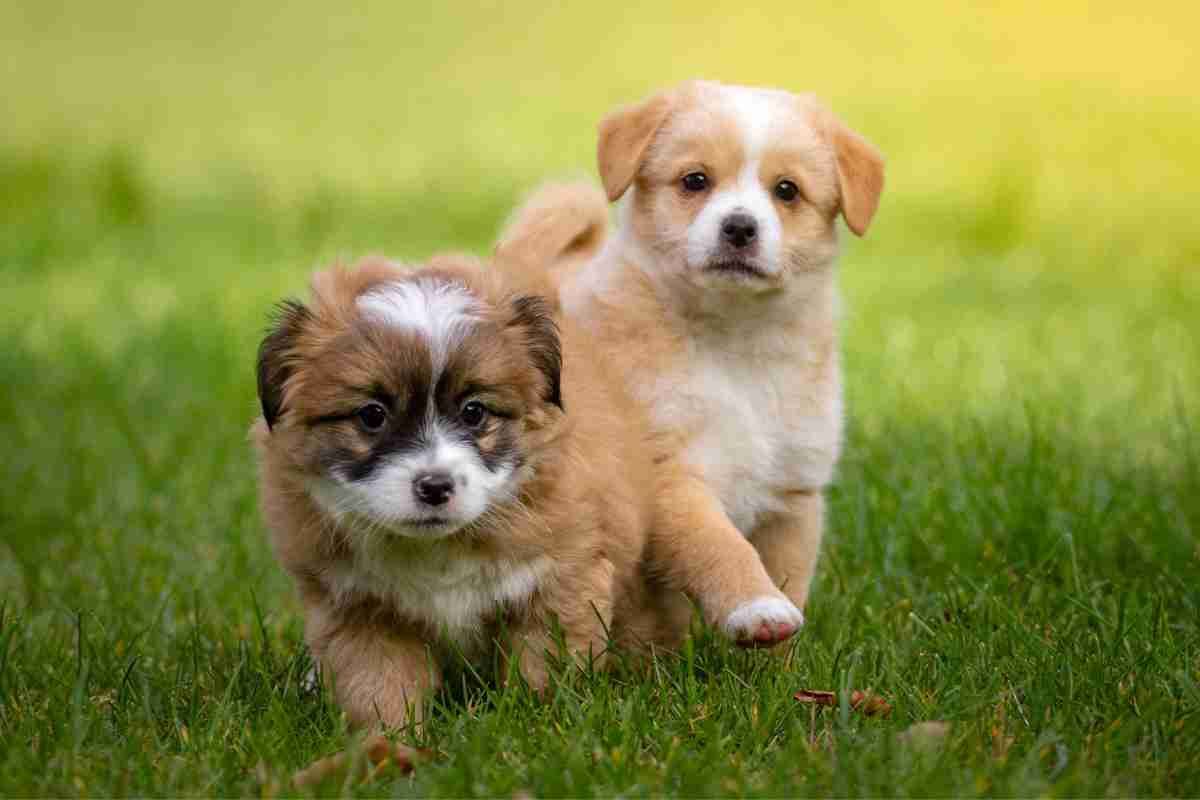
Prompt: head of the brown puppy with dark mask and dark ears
<box><xmin>258</xmin><ymin>256</ymin><xmax>562</xmax><ymax>539</ymax></box>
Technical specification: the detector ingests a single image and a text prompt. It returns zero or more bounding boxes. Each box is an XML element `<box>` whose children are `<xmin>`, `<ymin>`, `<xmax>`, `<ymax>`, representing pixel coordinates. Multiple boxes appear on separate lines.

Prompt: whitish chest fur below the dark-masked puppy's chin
<box><xmin>322</xmin><ymin>542</ymin><xmax>551</xmax><ymax>645</ymax></box>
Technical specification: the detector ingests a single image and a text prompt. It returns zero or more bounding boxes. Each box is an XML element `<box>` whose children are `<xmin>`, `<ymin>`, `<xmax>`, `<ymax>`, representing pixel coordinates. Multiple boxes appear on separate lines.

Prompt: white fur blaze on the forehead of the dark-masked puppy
<box><xmin>358</xmin><ymin>278</ymin><xmax>476</xmax><ymax>383</ymax></box>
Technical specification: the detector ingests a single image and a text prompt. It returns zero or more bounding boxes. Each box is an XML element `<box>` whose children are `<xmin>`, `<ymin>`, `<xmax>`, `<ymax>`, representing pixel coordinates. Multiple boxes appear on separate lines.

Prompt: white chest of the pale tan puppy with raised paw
<box><xmin>650</xmin><ymin>353</ymin><xmax>841</xmax><ymax>535</ymax></box>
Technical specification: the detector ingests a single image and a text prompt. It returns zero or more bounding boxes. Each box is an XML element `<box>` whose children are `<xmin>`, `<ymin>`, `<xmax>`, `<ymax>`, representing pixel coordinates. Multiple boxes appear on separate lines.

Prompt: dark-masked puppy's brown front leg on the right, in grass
<box><xmin>511</xmin><ymin>554</ymin><xmax>616</xmax><ymax>692</ymax></box>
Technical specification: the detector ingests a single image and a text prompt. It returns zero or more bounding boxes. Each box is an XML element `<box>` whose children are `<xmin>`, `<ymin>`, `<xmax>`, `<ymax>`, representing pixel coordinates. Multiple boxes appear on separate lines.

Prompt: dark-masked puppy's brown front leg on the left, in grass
<box><xmin>305</xmin><ymin>599</ymin><xmax>440</xmax><ymax>728</ymax></box>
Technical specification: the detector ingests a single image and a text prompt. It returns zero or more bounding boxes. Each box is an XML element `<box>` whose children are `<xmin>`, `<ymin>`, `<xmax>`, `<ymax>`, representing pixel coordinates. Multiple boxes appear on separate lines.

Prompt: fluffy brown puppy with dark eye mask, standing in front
<box><xmin>252</xmin><ymin>258</ymin><xmax>686</xmax><ymax>726</ymax></box>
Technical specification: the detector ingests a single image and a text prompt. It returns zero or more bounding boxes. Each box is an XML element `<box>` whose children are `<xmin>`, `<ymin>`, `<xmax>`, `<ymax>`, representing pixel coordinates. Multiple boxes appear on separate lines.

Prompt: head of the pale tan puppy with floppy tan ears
<box><xmin>598</xmin><ymin>82</ymin><xmax>883</xmax><ymax>290</ymax></box>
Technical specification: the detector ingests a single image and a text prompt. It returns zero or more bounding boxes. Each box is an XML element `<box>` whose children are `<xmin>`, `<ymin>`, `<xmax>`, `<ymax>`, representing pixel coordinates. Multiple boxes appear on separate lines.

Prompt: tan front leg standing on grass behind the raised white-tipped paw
<box><xmin>754</xmin><ymin>489</ymin><xmax>824</xmax><ymax>610</ymax></box>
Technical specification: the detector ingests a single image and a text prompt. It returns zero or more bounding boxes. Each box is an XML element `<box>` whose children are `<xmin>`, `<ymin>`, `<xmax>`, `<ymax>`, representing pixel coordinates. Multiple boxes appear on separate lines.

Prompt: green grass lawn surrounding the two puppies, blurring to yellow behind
<box><xmin>0</xmin><ymin>0</ymin><xmax>1200</xmax><ymax>796</ymax></box>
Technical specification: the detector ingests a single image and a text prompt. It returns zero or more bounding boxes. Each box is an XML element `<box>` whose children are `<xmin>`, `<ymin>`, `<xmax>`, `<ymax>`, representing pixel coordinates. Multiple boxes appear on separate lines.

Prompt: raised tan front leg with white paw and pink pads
<box><xmin>650</xmin><ymin>462</ymin><xmax>804</xmax><ymax>646</ymax></box>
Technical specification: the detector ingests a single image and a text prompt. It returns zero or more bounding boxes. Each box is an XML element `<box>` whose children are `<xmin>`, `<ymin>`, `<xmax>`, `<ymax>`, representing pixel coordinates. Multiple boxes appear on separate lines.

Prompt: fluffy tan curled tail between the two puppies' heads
<box><xmin>496</xmin><ymin>181</ymin><xmax>608</xmax><ymax>306</ymax></box>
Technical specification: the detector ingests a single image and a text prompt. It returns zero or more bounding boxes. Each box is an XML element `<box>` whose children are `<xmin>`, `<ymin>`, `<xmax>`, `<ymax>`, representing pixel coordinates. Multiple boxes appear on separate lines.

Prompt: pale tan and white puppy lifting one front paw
<box><xmin>499</xmin><ymin>82</ymin><xmax>883</xmax><ymax>644</ymax></box>
